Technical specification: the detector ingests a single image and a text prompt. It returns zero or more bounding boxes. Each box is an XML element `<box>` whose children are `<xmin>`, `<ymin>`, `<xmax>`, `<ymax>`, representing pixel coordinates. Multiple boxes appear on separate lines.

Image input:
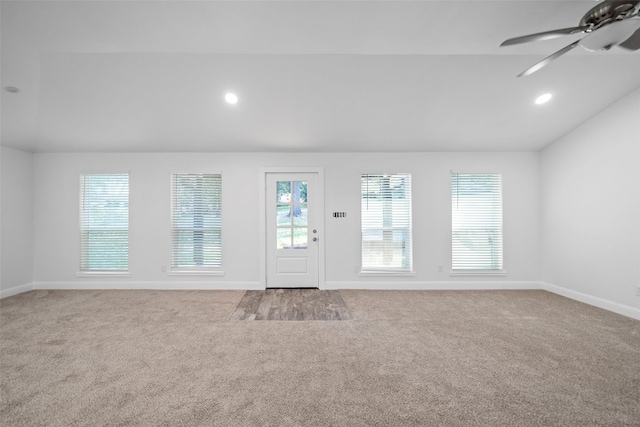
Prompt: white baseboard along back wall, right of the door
<box><xmin>325</xmin><ymin>280</ymin><xmax>540</xmax><ymax>291</ymax></box>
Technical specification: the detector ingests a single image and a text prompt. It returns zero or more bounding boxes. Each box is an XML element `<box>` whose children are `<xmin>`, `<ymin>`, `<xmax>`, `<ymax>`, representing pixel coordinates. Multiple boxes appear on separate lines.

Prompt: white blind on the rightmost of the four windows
<box><xmin>451</xmin><ymin>173</ymin><xmax>502</xmax><ymax>270</ymax></box>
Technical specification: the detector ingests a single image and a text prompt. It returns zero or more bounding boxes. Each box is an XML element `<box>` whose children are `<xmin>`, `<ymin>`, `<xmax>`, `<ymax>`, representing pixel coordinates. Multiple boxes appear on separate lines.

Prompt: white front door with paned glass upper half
<box><xmin>265</xmin><ymin>173</ymin><xmax>320</xmax><ymax>288</ymax></box>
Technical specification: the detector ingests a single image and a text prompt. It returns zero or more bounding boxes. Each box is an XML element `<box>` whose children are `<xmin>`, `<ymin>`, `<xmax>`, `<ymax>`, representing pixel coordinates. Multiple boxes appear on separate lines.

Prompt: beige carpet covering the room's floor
<box><xmin>0</xmin><ymin>291</ymin><xmax>640</xmax><ymax>426</ymax></box>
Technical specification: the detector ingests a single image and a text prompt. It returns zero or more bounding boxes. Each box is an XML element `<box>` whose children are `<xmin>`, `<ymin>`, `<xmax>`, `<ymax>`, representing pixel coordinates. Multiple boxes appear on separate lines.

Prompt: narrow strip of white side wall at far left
<box><xmin>0</xmin><ymin>147</ymin><xmax>33</xmax><ymax>298</ymax></box>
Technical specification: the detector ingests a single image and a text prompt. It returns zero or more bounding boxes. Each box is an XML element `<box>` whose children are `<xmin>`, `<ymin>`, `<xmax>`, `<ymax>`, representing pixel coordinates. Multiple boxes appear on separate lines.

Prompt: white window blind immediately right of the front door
<box><xmin>361</xmin><ymin>173</ymin><xmax>412</xmax><ymax>271</ymax></box>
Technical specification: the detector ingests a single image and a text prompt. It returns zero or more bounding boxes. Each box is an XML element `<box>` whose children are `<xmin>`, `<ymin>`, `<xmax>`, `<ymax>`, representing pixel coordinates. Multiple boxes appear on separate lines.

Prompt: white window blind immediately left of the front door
<box><xmin>171</xmin><ymin>174</ymin><xmax>222</xmax><ymax>269</ymax></box>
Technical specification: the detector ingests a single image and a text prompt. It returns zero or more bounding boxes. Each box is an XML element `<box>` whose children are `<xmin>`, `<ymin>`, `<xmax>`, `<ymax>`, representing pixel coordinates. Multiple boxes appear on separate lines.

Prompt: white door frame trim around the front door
<box><xmin>258</xmin><ymin>166</ymin><xmax>325</xmax><ymax>289</ymax></box>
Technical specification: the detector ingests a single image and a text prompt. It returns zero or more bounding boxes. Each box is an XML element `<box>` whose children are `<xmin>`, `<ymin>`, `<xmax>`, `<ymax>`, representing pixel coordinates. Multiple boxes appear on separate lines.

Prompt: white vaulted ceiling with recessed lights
<box><xmin>0</xmin><ymin>0</ymin><xmax>640</xmax><ymax>152</ymax></box>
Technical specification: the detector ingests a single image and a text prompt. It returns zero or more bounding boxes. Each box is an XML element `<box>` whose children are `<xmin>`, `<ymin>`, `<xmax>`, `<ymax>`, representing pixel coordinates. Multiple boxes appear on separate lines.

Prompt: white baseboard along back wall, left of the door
<box><xmin>33</xmin><ymin>280</ymin><xmax>263</xmax><ymax>291</ymax></box>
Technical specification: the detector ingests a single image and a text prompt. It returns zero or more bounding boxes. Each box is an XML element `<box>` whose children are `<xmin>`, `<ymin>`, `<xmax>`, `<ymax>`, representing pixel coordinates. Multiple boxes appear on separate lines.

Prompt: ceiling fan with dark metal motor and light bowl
<box><xmin>500</xmin><ymin>0</ymin><xmax>640</xmax><ymax>77</ymax></box>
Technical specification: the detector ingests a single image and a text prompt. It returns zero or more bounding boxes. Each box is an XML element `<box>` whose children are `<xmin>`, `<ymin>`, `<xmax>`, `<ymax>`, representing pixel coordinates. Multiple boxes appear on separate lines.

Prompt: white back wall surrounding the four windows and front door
<box><xmin>34</xmin><ymin>153</ymin><xmax>540</xmax><ymax>289</ymax></box>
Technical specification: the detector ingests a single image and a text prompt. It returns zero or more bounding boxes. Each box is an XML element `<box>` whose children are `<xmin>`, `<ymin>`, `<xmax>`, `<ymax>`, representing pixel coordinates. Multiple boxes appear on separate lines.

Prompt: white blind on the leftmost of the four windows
<box><xmin>80</xmin><ymin>174</ymin><xmax>129</xmax><ymax>271</ymax></box>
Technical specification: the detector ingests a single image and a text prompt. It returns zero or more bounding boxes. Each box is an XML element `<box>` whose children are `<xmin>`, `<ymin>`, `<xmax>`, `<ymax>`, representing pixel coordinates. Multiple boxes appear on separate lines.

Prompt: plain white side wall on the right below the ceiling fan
<box><xmin>541</xmin><ymin>89</ymin><xmax>640</xmax><ymax>318</ymax></box>
